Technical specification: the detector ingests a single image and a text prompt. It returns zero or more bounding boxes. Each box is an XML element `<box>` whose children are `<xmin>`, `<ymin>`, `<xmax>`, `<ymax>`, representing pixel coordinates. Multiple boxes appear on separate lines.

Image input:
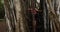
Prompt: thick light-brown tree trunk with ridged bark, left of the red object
<box><xmin>4</xmin><ymin>0</ymin><xmax>27</xmax><ymax>32</ymax></box>
